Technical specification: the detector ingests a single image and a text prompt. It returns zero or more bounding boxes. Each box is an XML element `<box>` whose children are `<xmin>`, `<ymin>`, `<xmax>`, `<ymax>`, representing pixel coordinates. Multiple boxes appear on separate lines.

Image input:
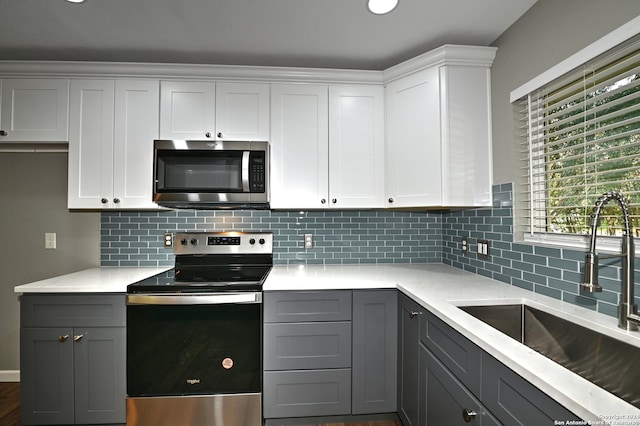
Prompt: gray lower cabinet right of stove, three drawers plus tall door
<box><xmin>263</xmin><ymin>290</ymin><xmax>397</xmax><ymax>418</ymax></box>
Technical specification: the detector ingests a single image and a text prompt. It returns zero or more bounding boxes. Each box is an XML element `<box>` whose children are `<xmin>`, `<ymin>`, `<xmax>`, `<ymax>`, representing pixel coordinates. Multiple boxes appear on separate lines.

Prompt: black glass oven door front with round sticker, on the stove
<box><xmin>127</xmin><ymin>304</ymin><xmax>262</xmax><ymax>396</ymax></box>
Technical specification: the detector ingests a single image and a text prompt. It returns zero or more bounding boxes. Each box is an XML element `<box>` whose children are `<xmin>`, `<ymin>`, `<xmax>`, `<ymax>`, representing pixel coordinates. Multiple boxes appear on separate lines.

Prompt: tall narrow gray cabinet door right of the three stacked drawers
<box><xmin>351</xmin><ymin>289</ymin><xmax>398</xmax><ymax>414</ymax></box>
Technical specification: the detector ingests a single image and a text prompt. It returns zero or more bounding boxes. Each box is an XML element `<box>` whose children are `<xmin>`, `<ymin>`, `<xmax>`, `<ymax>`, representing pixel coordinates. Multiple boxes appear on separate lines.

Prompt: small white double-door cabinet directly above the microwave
<box><xmin>160</xmin><ymin>81</ymin><xmax>269</xmax><ymax>140</ymax></box>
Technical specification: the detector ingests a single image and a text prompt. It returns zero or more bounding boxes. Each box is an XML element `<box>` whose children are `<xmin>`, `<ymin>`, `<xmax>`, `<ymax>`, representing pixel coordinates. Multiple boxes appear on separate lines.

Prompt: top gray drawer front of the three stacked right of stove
<box><xmin>264</xmin><ymin>290</ymin><xmax>351</xmax><ymax>322</ymax></box>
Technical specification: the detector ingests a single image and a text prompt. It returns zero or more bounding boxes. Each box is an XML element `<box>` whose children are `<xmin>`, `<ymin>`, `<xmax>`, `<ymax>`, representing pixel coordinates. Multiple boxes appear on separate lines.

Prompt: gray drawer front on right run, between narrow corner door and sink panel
<box><xmin>420</xmin><ymin>312</ymin><xmax>481</xmax><ymax>396</ymax></box>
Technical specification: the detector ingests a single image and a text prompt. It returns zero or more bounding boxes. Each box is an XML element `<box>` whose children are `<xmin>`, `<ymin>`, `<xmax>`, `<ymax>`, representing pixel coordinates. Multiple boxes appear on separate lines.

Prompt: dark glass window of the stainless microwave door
<box><xmin>156</xmin><ymin>150</ymin><xmax>242</xmax><ymax>192</ymax></box>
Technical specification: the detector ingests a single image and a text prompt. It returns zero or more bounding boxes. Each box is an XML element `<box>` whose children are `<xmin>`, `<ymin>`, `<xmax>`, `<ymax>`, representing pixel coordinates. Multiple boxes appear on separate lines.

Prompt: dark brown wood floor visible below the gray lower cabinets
<box><xmin>0</xmin><ymin>382</ymin><xmax>402</xmax><ymax>426</ymax></box>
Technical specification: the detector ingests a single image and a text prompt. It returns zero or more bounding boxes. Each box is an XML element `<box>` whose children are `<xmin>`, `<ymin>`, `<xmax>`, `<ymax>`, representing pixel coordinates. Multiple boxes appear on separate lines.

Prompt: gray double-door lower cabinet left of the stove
<box><xmin>20</xmin><ymin>294</ymin><xmax>126</xmax><ymax>425</ymax></box>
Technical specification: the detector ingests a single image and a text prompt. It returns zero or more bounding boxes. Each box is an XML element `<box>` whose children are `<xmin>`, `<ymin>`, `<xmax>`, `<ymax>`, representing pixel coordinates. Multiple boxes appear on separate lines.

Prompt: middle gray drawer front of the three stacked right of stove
<box><xmin>264</xmin><ymin>322</ymin><xmax>351</xmax><ymax>370</ymax></box>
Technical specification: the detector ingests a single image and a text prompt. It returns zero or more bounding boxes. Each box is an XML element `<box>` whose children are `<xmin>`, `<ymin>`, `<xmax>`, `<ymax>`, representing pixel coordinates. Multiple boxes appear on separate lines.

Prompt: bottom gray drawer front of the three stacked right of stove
<box><xmin>263</xmin><ymin>369</ymin><xmax>351</xmax><ymax>418</ymax></box>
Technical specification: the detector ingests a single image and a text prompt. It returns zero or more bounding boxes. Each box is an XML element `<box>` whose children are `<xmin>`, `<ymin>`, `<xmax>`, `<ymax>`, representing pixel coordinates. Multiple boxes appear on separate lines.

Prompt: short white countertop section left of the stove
<box><xmin>14</xmin><ymin>267</ymin><xmax>171</xmax><ymax>293</ymax></box>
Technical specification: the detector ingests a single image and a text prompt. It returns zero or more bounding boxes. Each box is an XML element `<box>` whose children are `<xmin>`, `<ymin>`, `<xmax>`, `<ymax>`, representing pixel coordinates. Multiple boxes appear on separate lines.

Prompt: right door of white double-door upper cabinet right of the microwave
<box><xmin>329</xmin><ymin>86</ymin><xmax>385</xmax><ymax>208</ymax></box>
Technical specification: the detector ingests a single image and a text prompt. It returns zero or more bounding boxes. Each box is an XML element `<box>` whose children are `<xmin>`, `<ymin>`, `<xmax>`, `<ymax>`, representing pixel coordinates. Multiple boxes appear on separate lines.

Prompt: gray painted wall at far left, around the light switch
<box><xmin>0</xmin><ymin>152</ymin><xmax>100</xmax><ymax>370</ymax></box>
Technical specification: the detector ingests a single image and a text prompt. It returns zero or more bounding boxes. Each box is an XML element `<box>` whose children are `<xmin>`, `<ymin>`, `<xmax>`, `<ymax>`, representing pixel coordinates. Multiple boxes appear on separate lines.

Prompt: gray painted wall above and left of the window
<box><xmin>491</xmin><ymin>0</ymin><xmax>640</xmax><ymax>187</ymax></box>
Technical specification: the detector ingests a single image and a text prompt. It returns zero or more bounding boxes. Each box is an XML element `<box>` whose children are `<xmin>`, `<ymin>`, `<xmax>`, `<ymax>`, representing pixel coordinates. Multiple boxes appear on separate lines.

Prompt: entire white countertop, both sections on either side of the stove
<box><xmin>15</xmin><ymin>264</ymin><xmax>640</xmax><ymax>425</ymax></box>
